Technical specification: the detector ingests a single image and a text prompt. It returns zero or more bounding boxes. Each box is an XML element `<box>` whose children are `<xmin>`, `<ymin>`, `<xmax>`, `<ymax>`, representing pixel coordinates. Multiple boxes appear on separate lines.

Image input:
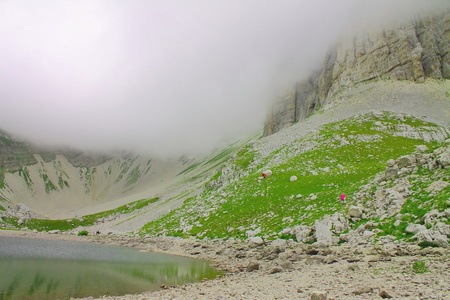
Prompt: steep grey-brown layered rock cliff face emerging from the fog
<box><xmin>264</xmin><ymin>12</ymin><xmax>450</xmax><ymax>136</ymax></box>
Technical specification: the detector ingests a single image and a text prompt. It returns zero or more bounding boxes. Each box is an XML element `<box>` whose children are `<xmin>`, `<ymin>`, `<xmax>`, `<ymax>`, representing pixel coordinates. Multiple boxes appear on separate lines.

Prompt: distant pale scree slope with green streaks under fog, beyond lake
<box><xmin>0</xmin><ymin>133</ymin><xmax>199</xmax><ymax>218</ymax></box>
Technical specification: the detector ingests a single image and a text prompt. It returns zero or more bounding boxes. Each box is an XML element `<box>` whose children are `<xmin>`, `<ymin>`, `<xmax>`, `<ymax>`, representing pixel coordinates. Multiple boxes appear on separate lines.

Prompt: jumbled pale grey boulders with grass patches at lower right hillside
<box><xmin>274</xmin><ymin>140</ymin><xmax>450</xmax><ymax>248</ymax></box>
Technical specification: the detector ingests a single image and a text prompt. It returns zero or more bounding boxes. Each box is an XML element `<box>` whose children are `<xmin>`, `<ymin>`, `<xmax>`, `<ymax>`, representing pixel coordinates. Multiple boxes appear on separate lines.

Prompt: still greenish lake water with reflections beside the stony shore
<box><xmin>0</xmin><ymin>237</ymin><xmax>219</xmax><ymax>300</ymax></box>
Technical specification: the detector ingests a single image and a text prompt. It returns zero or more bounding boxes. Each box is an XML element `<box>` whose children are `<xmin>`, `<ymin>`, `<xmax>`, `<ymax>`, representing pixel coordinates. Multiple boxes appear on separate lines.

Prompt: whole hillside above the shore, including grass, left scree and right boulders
<box><xmin>0</xmin><ymin>112</ymin><xmax>450</xmax><ymax>247</ymax></box>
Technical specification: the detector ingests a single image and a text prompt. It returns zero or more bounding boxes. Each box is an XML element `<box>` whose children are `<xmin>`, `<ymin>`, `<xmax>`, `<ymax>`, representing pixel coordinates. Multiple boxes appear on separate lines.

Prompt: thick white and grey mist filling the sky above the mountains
<box><xmin>0</xmin><ymin>0</ymin><xmax>449</xmax><ymax>155</ymax></box>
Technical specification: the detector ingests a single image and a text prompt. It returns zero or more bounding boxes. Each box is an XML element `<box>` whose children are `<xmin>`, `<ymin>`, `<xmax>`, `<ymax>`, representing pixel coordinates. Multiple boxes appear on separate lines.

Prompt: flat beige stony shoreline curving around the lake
<box><xmin>0</xmin><ymin>230</ymin><xmax>450</xmax><ymax>299</ymax></box>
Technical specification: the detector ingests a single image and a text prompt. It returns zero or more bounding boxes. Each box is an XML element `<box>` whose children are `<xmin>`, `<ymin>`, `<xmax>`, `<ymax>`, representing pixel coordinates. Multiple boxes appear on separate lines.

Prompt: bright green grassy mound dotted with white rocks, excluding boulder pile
<box><xmin>143</xmin><ymin>108</ymin><xmax>449</xmax><ymax>244</ymax></box>
